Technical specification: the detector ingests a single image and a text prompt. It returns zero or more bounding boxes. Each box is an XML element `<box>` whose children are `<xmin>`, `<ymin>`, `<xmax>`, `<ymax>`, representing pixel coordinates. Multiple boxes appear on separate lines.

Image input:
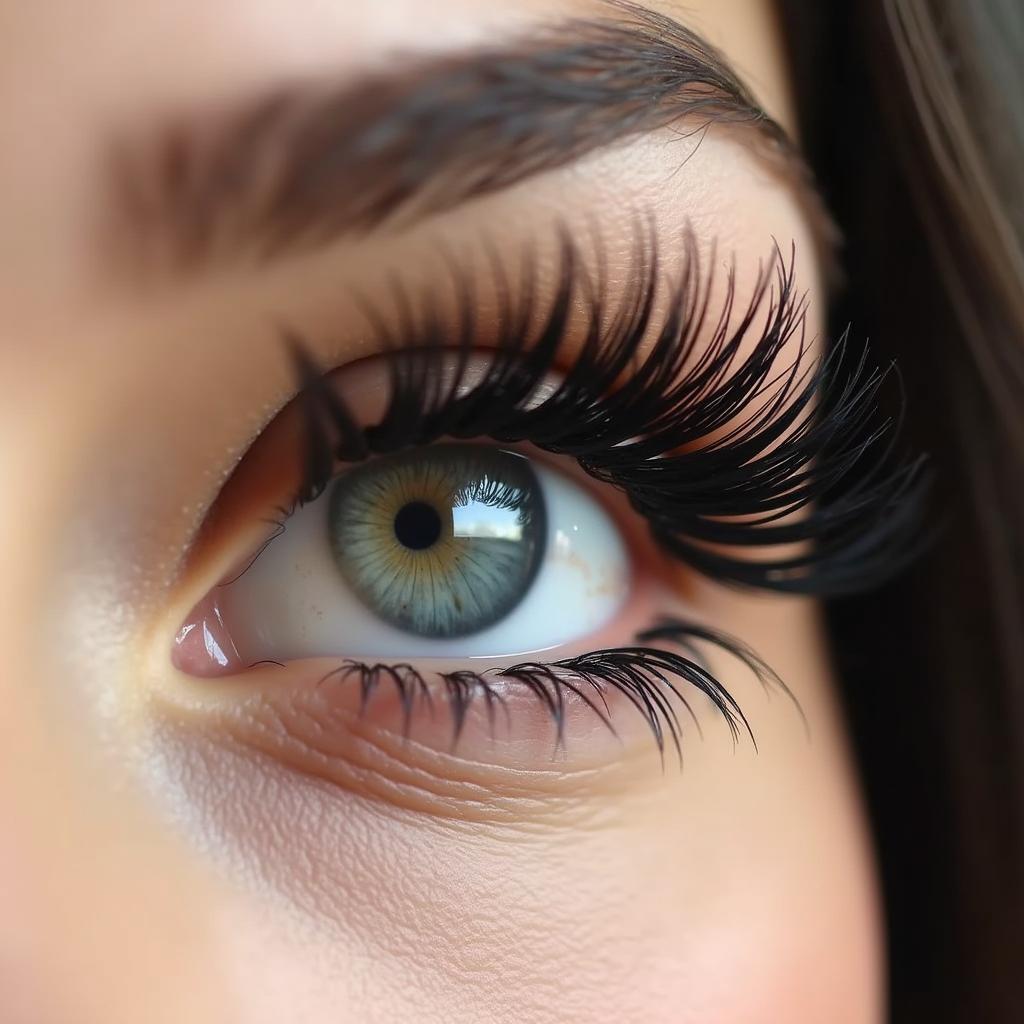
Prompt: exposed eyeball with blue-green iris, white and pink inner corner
<box><xmin>172</xmin><ymin>442</ymin><xmax>633</xmax><ymax>677</ymax></box>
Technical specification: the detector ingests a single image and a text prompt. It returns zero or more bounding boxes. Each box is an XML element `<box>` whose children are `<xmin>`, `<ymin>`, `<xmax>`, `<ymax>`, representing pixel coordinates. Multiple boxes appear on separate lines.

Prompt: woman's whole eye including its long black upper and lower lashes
<box><xmin>161</xmin><ymin>232</ymin><xmax>919</xmax><ymax>765</ymax></box>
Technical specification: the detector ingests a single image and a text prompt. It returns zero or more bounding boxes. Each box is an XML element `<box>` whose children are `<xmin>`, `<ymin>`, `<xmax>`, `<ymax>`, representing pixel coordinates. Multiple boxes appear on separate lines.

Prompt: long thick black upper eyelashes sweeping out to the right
<box><xmin>292</xmin><ymin>227</ymin><xmax>928</xmax><ymax>595</ymax></box>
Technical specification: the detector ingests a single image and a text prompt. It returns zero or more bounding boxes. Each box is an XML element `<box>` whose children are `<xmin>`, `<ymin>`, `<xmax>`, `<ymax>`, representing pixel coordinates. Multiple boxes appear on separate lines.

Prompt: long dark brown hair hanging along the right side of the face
<box><xmin>780</xmin><ymin>0</ymin><xmax>1024</xmax><ymax>1022</ymax></box>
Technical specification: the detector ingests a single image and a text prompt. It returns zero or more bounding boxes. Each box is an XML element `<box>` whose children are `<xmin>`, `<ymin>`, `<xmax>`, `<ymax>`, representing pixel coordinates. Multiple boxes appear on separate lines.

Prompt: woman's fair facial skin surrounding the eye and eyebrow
<box><xmin>0</xmin><ymin>0</ymin><xmax>882</xmax><ymax>1024</ymax></box>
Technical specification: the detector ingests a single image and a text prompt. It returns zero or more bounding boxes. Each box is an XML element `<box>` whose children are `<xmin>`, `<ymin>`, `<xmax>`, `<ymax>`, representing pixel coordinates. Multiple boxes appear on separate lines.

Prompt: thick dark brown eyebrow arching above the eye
<box><xmin>103</xmin><ymin>2</ymin><xmax>824</xmax><ymax>270</ymax></box>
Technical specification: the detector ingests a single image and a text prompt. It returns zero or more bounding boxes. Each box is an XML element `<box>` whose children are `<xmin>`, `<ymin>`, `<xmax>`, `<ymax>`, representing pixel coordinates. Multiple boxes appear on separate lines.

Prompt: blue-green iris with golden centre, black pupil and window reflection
<box><xmin>329</xmin><ymin>444</ymin><xmax>546</xmax><ymax>638</ymax></box>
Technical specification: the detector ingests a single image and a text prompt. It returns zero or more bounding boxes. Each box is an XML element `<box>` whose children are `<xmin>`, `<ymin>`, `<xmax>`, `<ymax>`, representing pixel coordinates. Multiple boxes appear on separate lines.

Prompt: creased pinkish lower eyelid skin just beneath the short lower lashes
<box><xmin>160</xmin><ymin>663</ymin><xmax>656</xmax><ymax>827</ymax></box>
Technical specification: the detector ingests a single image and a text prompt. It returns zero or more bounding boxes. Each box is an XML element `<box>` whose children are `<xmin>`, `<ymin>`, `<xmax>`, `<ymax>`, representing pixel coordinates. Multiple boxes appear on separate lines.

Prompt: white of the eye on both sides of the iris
<box><xmin>218</xmin><ymin>450</ymin><xmax>631</xmax><ymax>664</ymax></box>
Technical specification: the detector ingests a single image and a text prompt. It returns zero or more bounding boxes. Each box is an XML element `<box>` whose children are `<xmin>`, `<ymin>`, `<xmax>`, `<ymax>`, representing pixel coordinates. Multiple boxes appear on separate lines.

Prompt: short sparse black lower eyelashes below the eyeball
<box><xmin>321</xmin><ymin>620</ymin><xmax>786</xmax><ymax>763</ymax></box>
